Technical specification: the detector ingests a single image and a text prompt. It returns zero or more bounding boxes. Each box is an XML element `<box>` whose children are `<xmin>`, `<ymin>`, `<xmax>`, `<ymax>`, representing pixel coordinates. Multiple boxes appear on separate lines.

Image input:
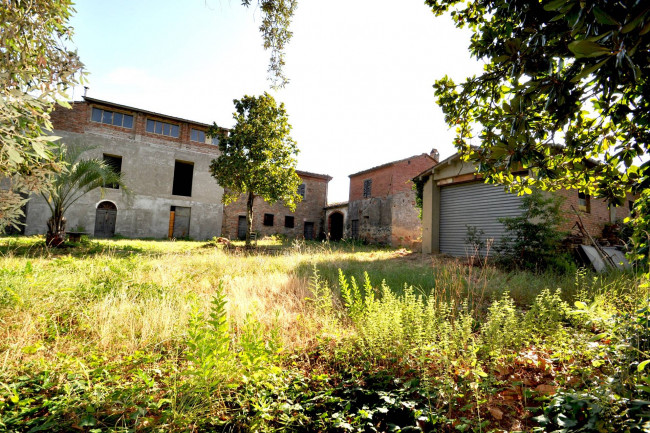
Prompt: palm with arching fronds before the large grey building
<box><xmin>41</xmin><ymin>147</ymin><xmax>131</xmax><ymax>247</ymax></box>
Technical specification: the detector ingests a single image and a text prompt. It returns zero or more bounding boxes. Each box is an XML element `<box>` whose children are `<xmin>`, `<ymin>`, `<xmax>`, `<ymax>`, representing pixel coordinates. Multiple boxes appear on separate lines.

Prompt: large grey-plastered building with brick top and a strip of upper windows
<box><xmin>25</xmin><ymin>97</ymin><xmax>223</xmax><ymax>239</ymax></box>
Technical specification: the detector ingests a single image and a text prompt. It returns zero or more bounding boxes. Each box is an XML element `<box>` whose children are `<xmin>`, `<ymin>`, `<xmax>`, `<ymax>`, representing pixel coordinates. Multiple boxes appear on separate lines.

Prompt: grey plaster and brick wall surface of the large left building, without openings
<box><xmin>26</xmin><ymin>103</ymin><xmax>223</xmax><ymax>239</ymax></box>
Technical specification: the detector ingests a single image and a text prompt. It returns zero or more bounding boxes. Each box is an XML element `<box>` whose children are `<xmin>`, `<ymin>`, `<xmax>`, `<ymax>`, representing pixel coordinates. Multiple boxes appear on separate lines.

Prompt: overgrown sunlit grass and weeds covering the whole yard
<box><xmin>0</xmin><ymin>237</ymin><xmax>650</xmax><ymax>432</ymax></box>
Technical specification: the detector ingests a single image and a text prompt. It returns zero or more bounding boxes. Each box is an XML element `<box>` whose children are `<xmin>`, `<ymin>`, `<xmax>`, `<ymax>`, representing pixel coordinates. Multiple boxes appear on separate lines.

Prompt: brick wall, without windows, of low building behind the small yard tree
<box><xmin>221</xmin><ymin>175</ymin><xmax>329</xmax><ymax>239</ymax></box>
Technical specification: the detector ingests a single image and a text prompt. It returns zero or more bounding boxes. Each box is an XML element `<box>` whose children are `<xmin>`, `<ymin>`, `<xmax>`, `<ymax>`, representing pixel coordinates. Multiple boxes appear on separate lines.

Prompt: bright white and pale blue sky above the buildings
<box><xmin>72</xmin><ymin>0</ymin><xmax>482</xmax><ymax>202</ymax></box>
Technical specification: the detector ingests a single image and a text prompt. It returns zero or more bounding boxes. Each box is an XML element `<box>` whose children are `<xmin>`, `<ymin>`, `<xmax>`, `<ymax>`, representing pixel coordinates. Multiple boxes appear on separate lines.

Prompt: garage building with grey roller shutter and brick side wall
<box><xmin>418</xmin><ymin>154</ymin><xmax>630</xmax><ymax>256</ymax></box>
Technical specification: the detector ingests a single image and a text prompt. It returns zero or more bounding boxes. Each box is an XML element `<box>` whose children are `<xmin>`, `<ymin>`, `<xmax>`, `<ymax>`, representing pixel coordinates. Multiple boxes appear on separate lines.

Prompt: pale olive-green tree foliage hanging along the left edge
<box><xmin>0</xmin><ymin>0</ymin><xmax>82</xmax><ymax>232</ymax></box>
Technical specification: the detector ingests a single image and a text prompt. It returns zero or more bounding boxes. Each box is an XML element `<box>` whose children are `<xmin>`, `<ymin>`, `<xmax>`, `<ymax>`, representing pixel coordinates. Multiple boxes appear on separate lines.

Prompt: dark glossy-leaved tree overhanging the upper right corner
<box><xmin>425</xmin><ymin>0</ymin><xmax>650</xmax><ymax>260</ymax></box>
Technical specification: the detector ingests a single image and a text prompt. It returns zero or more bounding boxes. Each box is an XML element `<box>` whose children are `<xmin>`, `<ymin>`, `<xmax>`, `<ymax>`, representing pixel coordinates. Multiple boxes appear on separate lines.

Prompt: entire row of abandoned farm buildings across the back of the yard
<box><xmin>16</xmin><ymin>97</ymin><xmax>631</xmax><ymax>251</ymax></box>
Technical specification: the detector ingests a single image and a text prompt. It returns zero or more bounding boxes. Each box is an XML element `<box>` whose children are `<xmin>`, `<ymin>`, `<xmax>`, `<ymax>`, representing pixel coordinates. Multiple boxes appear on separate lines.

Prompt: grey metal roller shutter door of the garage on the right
<box><xmin>440</xmin><ymin>183</ymin><xmax>521</xmax><ymax>257</ymax></box>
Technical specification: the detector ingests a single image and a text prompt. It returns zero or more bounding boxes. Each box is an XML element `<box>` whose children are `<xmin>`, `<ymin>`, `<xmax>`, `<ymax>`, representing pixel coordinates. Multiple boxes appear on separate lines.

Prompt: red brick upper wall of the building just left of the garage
<box><xmin>349</xmin><ymin>154</ymin><xmax>435</xmax><ymax>201</ymax></box>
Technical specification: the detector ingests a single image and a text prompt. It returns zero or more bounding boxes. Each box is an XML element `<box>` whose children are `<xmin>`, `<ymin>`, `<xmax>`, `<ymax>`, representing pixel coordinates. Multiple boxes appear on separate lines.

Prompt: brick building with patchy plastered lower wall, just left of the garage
<box><xmin>346</xmin><ymin>149</ymin><xmax>438</xmax><ymax>247</ymax></box>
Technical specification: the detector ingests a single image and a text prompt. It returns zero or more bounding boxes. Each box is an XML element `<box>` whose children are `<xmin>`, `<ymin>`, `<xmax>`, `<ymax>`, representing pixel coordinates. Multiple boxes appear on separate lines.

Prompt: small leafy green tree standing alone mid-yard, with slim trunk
<box><xmin>208</xmin><ymin>92</ymin><xmax>302</xmax><ymax>248</ymax></box>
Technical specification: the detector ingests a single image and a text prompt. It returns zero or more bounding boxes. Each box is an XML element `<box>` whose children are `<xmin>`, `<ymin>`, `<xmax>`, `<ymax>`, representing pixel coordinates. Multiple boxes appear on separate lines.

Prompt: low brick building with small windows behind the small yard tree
<box><xmin>222</xmin><ymin>170</ymin><xmax>332</xmax><ymax>240</ymax></box>
